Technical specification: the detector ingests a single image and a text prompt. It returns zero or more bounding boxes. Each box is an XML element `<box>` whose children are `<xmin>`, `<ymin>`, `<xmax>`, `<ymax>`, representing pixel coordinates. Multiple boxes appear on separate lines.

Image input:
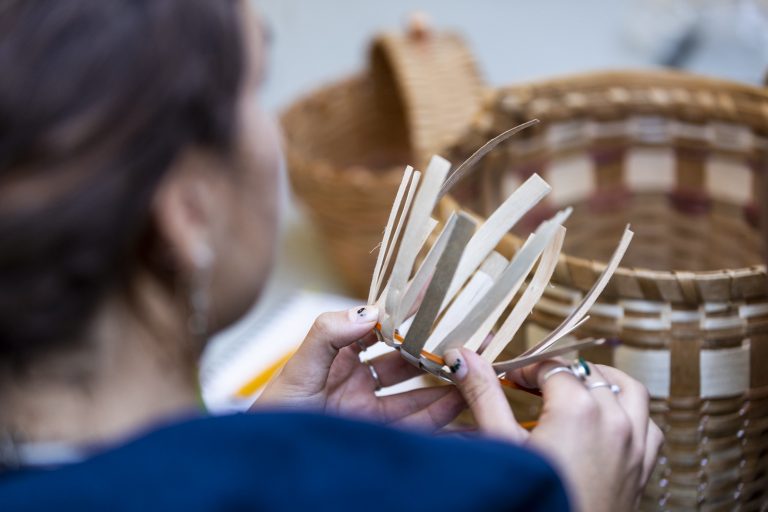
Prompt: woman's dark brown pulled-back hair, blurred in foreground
<box><xmin>0</xmin><ymin>0</ymin><xmax>244</xmax><ymax>361</ymax></box>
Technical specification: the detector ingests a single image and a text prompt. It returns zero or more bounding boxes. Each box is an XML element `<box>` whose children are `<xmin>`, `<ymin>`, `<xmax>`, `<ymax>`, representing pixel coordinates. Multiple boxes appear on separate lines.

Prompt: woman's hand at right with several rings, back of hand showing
<box><xmin>445</xmin><ymin>349</ymin><xmax>663</xmax><ymax>512</ymax></box>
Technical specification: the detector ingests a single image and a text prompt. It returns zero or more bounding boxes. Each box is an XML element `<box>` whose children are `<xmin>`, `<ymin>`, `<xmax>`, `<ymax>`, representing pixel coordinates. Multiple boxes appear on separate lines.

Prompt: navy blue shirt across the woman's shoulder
<box><xmin>0</xmin><ymin>413</ymin><xmax>568</xmax><ymax>512</ymax></box>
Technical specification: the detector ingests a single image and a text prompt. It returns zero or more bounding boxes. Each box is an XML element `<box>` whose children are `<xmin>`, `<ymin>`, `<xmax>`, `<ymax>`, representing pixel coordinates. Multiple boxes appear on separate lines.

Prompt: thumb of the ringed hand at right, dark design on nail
<box><xmin>444</xmin><ymin>348</ymin><xmax>528</xmax><ymax>442</ymax></box>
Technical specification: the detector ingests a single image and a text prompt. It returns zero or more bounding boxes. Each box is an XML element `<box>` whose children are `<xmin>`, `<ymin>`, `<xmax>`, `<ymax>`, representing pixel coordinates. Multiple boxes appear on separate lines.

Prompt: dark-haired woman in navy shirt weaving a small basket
<box><xmin>0</xmin><ymin>0</ymin><xmax>661</xmax><ymax>511</ymax></box>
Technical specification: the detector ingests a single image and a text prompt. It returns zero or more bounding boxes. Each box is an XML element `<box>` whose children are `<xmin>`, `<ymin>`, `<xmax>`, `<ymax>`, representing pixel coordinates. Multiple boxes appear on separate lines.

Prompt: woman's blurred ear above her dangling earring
<box><xmin>152</xmin><ymin>150</ymin><xmax>226</xmax><ymax>275</ymax></box>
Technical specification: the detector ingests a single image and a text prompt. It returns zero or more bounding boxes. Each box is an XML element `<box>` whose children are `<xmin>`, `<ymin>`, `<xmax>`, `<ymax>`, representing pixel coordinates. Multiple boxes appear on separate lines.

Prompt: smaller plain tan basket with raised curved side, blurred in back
<box><xmin>282</xmin><ymin>23</ymin><xmax>483</xmax><ymax>296</ymax></box>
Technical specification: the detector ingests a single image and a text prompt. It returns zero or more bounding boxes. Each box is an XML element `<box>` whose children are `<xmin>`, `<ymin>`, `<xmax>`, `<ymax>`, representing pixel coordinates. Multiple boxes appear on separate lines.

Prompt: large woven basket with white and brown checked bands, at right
<box><xmin>440</xmin><ymin>71</ymin><xmax>768</xmax><ymax>510</ymax></box>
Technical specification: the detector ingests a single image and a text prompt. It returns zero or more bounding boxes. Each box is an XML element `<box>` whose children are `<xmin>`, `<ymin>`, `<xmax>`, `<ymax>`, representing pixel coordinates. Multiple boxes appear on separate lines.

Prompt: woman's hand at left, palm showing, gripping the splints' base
<box><xmin>254</xmin><ymin>306</ymin><xmax>465</xmax><ymax>430</ymax></box>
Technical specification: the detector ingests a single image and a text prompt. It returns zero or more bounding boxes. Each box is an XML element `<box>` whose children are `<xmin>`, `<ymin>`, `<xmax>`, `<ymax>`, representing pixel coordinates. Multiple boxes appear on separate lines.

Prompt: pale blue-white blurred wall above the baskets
<box><xmin>254</xmin><ymin>0</ymin><xmax>768</xmax><ymax>112</ymax></box>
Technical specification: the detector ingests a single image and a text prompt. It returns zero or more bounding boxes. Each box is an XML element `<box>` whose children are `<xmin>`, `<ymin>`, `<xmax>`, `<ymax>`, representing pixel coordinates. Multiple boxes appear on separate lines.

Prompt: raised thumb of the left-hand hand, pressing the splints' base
<box><xmin>282</xmin><ymin>306</ymin><xmax>379</xmax><ymax>388</ymax></box>
